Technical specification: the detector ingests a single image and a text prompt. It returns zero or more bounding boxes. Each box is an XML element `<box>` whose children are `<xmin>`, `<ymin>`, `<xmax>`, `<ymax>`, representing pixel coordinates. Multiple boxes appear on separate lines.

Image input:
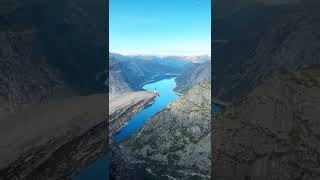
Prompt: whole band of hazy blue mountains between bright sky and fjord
<box><xmin>109</xmin><ymin>53</ymin><xmax>211</xmax><ymax>97</ymax></box>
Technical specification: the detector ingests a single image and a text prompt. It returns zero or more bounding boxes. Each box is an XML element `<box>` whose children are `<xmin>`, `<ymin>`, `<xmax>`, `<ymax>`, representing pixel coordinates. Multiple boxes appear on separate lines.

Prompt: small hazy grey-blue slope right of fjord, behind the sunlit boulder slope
<box><xmin>174</xmin><ymin>61</ymin><xmax>211</xmax><ymax>93</ymax></box>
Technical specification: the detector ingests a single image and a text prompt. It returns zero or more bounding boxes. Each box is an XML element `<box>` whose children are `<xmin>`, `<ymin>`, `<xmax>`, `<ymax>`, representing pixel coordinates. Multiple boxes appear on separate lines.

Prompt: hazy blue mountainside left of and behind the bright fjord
<box><xmin>108</xmin><ymin>53</ymin><xmax>193</xmax><ymax>97</ymax></box>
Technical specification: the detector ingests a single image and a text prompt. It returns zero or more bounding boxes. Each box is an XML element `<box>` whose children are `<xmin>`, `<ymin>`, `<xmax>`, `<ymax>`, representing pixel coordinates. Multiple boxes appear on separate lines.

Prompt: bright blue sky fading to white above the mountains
<box><xmin>109</xmin><ymin>0</ymin><xmax>211</xmax><ymax>55</ymax></box>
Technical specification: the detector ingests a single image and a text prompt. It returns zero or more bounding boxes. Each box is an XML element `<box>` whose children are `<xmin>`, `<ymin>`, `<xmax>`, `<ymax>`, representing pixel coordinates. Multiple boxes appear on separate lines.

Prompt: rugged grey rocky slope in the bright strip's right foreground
<box><xmin>113</xmin><ymin>83</ymin><xmax>211</xmax><ymax>179</ymax></box>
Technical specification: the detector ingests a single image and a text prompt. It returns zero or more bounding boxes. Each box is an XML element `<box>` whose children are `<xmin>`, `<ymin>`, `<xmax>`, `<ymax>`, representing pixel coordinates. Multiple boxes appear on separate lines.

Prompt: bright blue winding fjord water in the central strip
<box><xmin>114</xmin><ymin>77</ymin><xmax>177</xmax><ymax>141</ymax></box>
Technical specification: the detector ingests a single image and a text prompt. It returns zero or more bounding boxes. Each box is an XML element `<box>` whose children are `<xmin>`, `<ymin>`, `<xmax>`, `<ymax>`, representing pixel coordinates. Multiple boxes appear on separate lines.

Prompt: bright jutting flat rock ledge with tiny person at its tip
<box><xmin>109</xmin><ymin>91</ymin><xmax>156</xmax><ymax>137</ymax></box>
